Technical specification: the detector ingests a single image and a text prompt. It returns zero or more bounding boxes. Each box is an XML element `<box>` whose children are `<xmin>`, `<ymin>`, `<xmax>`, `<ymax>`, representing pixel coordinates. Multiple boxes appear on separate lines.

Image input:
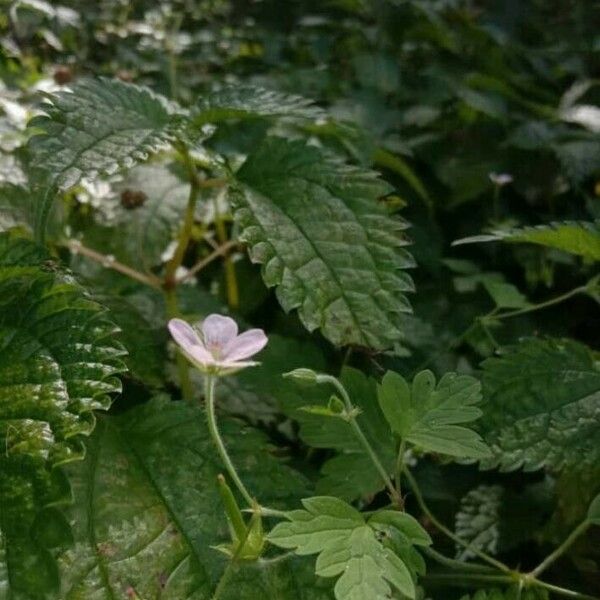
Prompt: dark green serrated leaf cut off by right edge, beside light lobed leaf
<box><xmin>480</xmin><ymin>339</ymin><xmax>600</xmax><ymax>471</ymax></box>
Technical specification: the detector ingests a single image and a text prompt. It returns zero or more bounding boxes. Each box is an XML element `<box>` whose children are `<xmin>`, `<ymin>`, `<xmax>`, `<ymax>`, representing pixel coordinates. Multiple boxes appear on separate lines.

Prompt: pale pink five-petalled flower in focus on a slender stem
<box><xmin>169</xmin><ymin>315</ymin><xmax>268</xmax><ymax>375</ymax></box>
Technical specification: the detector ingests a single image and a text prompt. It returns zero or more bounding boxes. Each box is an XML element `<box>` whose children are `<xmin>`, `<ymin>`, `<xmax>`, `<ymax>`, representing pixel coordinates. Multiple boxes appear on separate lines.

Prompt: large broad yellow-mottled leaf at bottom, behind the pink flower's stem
<box><xmin>59</xmin><ymin>396</ymin><xmax>331</xmax><ymax>600</ymax></box>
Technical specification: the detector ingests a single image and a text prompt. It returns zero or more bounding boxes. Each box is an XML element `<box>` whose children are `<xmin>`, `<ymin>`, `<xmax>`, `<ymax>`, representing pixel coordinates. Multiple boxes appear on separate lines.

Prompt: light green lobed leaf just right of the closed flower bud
<box><xmin>378</xmin><ymin>371</ymin><xmax>489</xmax><ymax>458</ymax></box>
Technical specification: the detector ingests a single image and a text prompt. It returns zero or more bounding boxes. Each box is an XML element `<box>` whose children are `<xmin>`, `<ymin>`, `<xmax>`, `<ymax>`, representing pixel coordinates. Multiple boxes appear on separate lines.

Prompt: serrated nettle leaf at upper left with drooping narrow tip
<box><xmin>29</xmin><ymin>79</ymin><xmax>182</xmax><ymax>239</ymax></box>
